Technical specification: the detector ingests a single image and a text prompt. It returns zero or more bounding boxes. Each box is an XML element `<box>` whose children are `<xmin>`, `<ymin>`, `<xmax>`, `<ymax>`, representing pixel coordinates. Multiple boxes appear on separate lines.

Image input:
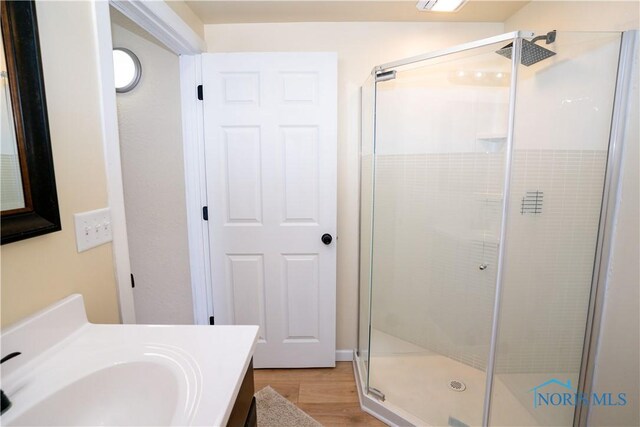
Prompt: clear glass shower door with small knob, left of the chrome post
<box><xmin>368</xmin><ymin>42</ymin><xmax>511</xmax><ymax>426</ymax></box>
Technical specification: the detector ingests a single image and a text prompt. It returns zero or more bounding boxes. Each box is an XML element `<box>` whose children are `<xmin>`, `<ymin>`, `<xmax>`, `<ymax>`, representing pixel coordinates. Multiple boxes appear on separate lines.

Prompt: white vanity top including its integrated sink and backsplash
<box><xmin>0</xmin><ymin>295</ymin><xmax>258</xmax><ymax>426</ymax></box>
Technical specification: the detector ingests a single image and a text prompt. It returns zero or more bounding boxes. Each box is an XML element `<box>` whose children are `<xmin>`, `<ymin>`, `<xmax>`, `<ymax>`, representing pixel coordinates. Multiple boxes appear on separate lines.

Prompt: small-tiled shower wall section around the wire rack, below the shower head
<box><xmin>496</xmin><ymin>150</ymin><xmax>607</xmax><ymax>373</ymax></box>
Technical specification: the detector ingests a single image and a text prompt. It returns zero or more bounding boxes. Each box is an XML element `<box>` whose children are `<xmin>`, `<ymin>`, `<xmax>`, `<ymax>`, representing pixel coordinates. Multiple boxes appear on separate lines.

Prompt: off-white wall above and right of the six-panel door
<box><xmin>205</xmin><ymin>22</ymin><xmax>503</xmax><ymax>349</ymax></box>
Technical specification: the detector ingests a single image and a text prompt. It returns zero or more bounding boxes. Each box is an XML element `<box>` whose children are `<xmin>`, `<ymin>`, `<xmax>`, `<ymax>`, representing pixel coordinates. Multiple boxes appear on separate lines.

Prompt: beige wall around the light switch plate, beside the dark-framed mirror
<box><xmin>1</xmin><ymin>2</ymin><xmax>119</xmax><ymax>326</ymax></box>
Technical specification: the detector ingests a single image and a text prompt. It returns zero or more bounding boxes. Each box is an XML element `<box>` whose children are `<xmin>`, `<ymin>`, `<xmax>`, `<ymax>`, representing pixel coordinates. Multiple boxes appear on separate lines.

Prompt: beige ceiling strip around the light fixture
<box><xmin>186</xmin><ymin>0</ymin><xmax>528</xmax><ymax>24</ymax></box>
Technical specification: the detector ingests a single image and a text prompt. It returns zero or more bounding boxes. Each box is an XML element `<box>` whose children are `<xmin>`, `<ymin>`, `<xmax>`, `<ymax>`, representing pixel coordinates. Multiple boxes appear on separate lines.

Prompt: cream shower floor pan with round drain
<box><xmin>356</xmin><ymin>329</ymin><xmax>575</xmax><ymax>427</ymax></box>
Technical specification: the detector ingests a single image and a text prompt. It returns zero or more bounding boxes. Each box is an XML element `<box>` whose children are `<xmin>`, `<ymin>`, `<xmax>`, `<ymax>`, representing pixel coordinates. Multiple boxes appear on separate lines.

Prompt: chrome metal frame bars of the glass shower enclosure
<box><xmin>353</xmin><ymin>31</ymin><xmax>640</xmax><ymax>426</ymax></box>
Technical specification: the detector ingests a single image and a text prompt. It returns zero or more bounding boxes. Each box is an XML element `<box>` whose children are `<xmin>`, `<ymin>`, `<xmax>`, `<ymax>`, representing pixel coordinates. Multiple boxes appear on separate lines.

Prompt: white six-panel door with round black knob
<box><xmin>202</xmin><ymin>53</ymin><xmax>337</xmax><ymax>368</ymax></box>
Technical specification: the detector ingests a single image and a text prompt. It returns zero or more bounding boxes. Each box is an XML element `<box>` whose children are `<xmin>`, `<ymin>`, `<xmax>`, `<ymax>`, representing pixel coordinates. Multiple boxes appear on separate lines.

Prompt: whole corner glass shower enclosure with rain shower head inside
<box><xmin>356</xmin><ymin>31</ymin><xmax>629</xmax><ymax>427</ymax></box>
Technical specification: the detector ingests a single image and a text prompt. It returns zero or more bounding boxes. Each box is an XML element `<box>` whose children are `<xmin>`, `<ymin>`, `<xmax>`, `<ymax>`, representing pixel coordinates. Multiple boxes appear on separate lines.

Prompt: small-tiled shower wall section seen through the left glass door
<box><xmin>372</xmin><ymin>153</ymin><xmax>504</xmax><ymax>367</ymax></box>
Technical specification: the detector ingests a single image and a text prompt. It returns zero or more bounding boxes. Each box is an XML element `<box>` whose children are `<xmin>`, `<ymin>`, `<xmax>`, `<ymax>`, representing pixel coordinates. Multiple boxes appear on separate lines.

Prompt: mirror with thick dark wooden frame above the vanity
<box><xmin>0</xmin><ymin>0</ymin><xmax>61</xmax><ymax>244</ymax></box>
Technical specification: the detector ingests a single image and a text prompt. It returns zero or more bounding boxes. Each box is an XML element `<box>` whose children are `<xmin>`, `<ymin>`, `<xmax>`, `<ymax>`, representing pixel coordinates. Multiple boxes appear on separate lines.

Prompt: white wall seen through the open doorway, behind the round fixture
<box><xmin>111</xmin><ymin>9</ymin><xmax>193</xmax><ymax>324</ymax></box>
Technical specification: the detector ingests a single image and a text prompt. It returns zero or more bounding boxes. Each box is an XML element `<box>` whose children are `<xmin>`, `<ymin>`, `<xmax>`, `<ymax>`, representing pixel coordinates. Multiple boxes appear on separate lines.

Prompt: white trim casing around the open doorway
<box><xmin>92</xmin><ymin>0</ymin><xmax>210</xmax><ymax>323</ymax></box>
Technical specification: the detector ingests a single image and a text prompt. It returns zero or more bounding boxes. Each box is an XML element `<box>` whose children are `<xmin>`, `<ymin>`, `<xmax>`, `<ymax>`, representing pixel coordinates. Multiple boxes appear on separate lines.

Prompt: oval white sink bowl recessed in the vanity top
<box><xmin>12</xmin><ymin>362</ymin><xmax>179</xmax><ymax>426</ymax></box>
